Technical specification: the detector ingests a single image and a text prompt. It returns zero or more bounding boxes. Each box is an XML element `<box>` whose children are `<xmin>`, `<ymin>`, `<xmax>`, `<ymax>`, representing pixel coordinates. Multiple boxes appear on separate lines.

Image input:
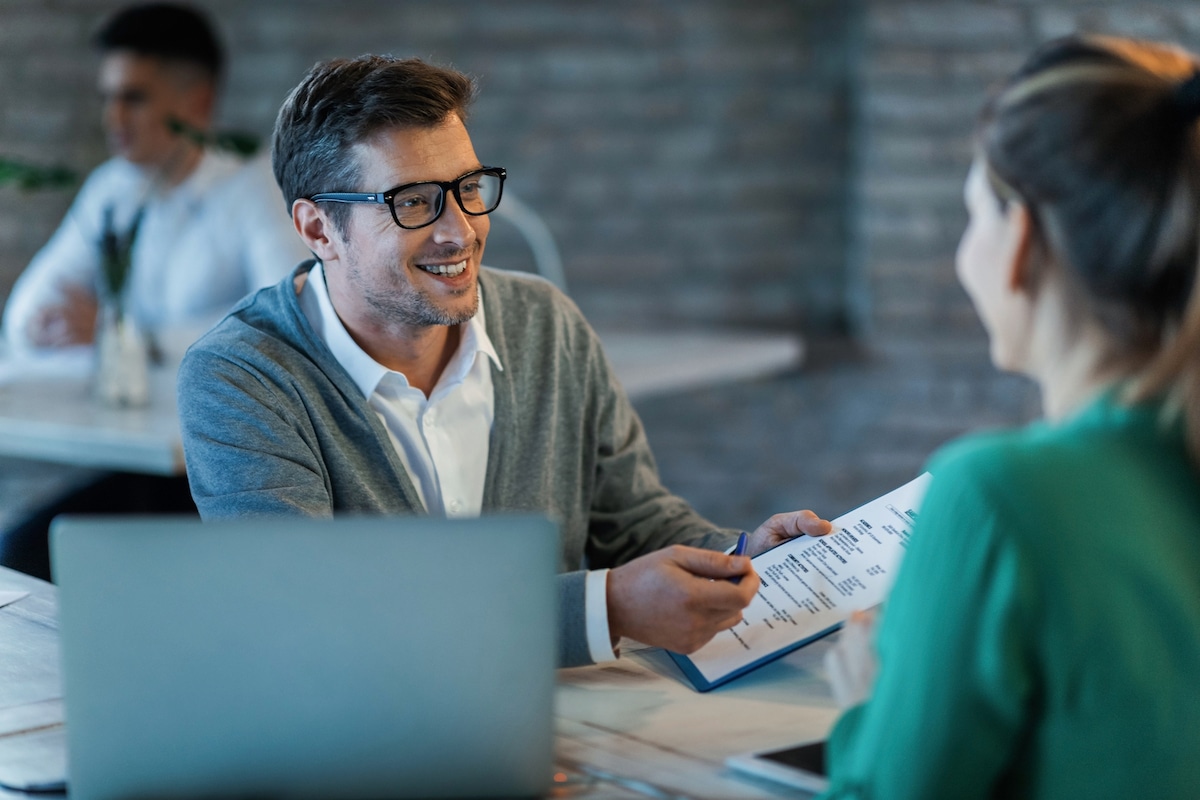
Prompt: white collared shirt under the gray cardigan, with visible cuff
<box><xmin>300</xmin><ymin>263</ymin><xmax>617</xmax><ymax>662</ymax></box>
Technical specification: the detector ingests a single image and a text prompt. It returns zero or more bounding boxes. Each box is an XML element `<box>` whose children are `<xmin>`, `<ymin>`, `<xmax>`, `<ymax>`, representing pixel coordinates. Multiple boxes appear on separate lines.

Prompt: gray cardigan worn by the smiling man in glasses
<box><xmin>179</xmin><ymin>261</ymin><xmax>733</xmax><ymax>666</ymax></box>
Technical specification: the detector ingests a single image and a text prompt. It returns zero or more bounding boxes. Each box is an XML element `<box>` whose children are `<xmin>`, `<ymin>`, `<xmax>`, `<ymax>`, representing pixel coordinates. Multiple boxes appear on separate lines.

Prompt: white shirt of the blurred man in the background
<box><xmin>4</xmin><ymin>151</ymin><xmax>310</xmax><ymax>355</ymax></box>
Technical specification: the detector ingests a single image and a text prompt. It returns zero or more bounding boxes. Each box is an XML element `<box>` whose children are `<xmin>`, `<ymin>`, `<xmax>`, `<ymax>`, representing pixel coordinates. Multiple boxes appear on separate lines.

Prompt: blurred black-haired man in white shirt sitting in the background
<box><xmin>4</xmin><ymin>4</ymin><xmax>307</xmax><ymax>355</ymax></box>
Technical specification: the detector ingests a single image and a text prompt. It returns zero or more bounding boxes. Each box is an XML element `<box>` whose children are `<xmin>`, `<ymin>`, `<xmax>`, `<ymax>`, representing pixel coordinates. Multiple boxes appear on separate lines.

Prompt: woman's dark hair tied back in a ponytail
<box><xmin>979</xmin><ymin>37</ymin><xmax>1200</xmax><ymax>463</ymax></box>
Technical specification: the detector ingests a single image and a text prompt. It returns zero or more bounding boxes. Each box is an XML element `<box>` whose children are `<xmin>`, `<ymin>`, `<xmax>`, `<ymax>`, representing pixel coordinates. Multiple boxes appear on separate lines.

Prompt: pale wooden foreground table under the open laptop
<box><xmin>0</xmin><ymin>567</ymin><xmax>836</xmax><ymax>800</ymax></box>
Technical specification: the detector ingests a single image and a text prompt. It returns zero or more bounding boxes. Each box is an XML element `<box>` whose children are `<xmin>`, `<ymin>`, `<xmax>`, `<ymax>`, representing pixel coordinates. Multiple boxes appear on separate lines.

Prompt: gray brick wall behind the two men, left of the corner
<box><xmin>0</xmin><ymin>0</ymin><xmax>857</xmax><ymax>327</ymax></box>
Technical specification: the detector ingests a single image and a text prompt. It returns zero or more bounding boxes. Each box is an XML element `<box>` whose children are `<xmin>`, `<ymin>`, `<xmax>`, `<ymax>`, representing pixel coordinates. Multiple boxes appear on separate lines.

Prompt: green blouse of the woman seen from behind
<box><xmin>824</xmin><ymin>396</ymin><xmax>1200</xmax><ymax>800</ymax></box>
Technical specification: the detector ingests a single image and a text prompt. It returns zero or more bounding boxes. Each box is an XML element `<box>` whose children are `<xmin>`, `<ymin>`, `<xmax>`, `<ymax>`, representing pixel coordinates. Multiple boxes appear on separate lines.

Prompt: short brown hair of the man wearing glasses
<box><xmin>271</xmin><ymin>55</ymin><xmax>475</xmax><ymax>230</ymax></box>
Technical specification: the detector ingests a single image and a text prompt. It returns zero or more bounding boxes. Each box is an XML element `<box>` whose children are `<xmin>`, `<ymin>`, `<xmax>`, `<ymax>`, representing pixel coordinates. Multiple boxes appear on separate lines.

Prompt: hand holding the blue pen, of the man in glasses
<box><xmin>607</xmin><ymin>545</ymin><xmax>758</xmax><ymax>654</ymax></box>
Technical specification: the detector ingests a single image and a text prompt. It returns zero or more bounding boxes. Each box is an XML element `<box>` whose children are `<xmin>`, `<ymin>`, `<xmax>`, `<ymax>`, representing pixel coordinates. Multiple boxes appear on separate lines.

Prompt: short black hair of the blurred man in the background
<box><xmin>92</xmin><ymin>2</ymin><xmax>224</xmax><ymax>83</ymax></box>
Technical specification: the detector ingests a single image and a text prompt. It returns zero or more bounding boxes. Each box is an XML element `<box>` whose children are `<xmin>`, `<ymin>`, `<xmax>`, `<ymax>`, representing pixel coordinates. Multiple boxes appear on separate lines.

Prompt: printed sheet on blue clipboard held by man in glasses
<box><xmin>672</xmin><ymin>473</ymin><xmax>931</xmax><ymax>690</ymax></box>
